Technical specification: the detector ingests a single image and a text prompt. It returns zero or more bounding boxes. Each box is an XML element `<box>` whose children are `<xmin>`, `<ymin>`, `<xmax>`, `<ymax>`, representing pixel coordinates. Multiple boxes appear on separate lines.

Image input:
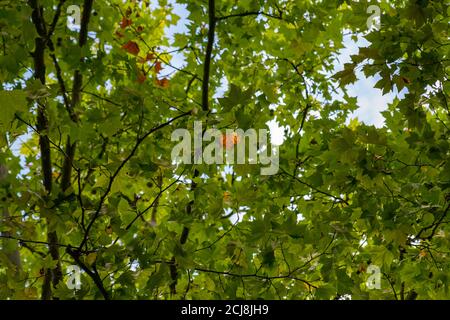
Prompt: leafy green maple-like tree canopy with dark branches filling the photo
<box><xmin>0</xmin><ymin>0</ymin><xmax>450</xmax><ymax>300</ymax></box>
